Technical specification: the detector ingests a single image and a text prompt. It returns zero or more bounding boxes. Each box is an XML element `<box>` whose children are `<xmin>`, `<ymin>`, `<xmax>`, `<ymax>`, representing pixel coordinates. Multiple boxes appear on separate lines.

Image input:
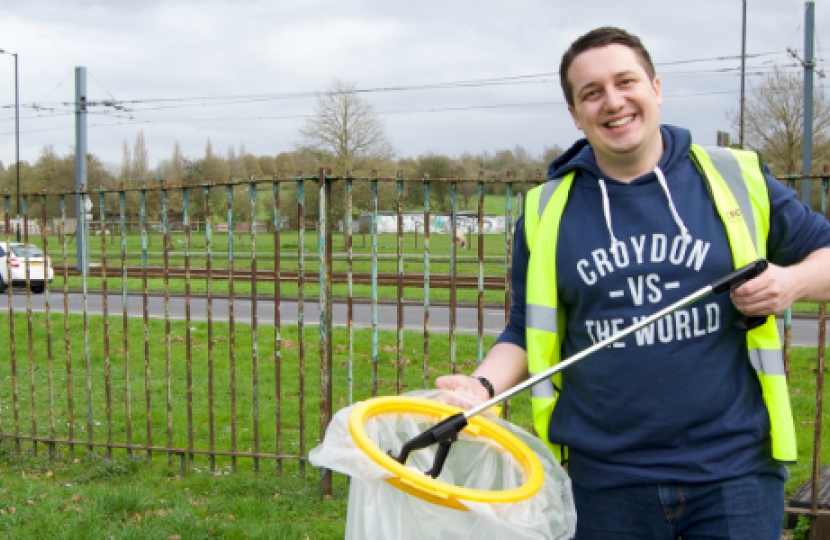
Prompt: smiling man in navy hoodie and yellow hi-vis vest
<box><xmin>436</xmin><ymin>27</ymin><xmax>830</xmax><ymax>540</ymax></box>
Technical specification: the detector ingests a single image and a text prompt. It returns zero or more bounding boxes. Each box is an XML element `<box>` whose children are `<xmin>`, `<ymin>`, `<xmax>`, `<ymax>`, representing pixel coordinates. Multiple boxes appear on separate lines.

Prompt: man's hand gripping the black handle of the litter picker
<box><xmin>731</xmin><ymin>263</ymin><xmax>803</xmax><ymax>317</ymax></box>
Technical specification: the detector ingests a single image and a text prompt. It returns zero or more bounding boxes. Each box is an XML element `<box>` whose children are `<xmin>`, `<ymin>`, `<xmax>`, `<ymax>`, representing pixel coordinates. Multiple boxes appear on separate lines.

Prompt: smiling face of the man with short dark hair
<box><xmin>568</xmin><ymin>44</ymin><xmax>663</xmax><ymax>174</ymax></box>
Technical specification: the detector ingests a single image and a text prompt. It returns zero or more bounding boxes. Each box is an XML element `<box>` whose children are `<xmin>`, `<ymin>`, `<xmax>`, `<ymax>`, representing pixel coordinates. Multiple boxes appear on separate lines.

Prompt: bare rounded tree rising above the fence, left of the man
<box><xmin>300</xmin><ymin>80</ymin><xmax>394</xmax><ymax>173</ymax></box>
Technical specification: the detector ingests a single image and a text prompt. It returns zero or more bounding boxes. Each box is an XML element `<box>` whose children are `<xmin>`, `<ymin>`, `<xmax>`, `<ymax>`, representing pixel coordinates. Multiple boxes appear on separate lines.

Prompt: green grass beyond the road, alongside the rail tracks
<box><xmin>47</xmin><ymin>227</ymin><xmax>520</xmax><ymax>304</ymax></box>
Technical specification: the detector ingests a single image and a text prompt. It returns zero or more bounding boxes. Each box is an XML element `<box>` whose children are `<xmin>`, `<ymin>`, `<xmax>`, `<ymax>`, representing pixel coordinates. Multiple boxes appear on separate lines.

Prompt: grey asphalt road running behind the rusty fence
<box><xmin>0</xmin><ymin>291</ymin><xmax>830</xmax><ymax>347</ymax></box>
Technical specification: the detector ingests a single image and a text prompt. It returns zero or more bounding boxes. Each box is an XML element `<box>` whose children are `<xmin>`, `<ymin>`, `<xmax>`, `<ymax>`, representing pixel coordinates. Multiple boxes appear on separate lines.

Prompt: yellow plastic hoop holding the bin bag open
<box><xmin>349</xmin><ymin>396</ymin><xmax>544</xmax><ymax>512</ymax></box>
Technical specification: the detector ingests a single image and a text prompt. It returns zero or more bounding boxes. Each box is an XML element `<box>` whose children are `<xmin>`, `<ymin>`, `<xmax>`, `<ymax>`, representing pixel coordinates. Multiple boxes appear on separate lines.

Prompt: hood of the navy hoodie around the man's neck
<box><xmin>548</xmin><ymin>125</ymin><xmax>692</xmax><ymax>182</ymax></box>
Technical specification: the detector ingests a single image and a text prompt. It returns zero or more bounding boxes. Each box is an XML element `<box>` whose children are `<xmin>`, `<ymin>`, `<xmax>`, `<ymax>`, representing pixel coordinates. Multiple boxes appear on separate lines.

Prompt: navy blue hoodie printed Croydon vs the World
<box><xmin>498</xmin><ymin>126</ymin><xmax>830</xmax><ymax>489</ymax></box>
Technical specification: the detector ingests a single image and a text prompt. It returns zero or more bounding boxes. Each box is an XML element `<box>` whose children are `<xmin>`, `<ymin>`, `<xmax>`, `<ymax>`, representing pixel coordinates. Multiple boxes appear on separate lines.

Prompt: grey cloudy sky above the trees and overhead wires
<box><xmin>0</xmin><ymin>0</ymin><xmax>830</xmax><ymax>173</ymax></box>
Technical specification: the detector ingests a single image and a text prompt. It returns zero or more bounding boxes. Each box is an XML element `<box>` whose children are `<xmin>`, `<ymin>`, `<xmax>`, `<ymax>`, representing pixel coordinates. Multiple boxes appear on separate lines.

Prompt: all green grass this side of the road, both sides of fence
<box><xmin>0</xmin><ymin>308</ymin><xmax>830</xmax><ymax>539</ymax></box>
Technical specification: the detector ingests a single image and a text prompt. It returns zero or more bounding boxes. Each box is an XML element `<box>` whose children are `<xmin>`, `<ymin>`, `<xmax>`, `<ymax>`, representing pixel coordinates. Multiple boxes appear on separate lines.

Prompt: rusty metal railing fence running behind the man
<box><xmin>0</xmin><ymin>170</ymin><xmax>828</xmax><ymax>516</ymax></box>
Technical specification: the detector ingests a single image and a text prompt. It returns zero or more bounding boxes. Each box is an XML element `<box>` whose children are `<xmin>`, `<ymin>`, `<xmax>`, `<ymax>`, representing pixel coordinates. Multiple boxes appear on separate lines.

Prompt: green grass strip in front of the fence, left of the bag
<box><xmin>0</xmin><ymin>454</ymin><xmax>348</xmax><ymax>540</ymax></box>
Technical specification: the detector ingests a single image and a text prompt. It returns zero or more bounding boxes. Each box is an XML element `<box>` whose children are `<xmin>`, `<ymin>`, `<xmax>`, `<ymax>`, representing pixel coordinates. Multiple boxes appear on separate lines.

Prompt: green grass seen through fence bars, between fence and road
<box><xmin>0</xmin><ymin>313</ymin><xmax>508</xmax><ymax>465</ymax></box>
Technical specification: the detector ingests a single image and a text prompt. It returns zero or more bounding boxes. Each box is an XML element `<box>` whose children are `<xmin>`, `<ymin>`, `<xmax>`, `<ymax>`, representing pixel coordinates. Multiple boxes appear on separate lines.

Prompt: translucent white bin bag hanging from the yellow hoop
<box><xmin>309</xmin><ymin>390</ymin><xmax>576</xmax><ymax>540</ymax></box>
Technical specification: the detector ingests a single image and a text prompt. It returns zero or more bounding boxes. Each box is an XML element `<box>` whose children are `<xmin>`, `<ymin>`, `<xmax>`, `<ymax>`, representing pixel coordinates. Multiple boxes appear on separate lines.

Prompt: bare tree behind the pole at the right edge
<box><xmin>729</xmin><ymin>66</ymin><xmax>830</xmax><ymax>175</ymax></box>
